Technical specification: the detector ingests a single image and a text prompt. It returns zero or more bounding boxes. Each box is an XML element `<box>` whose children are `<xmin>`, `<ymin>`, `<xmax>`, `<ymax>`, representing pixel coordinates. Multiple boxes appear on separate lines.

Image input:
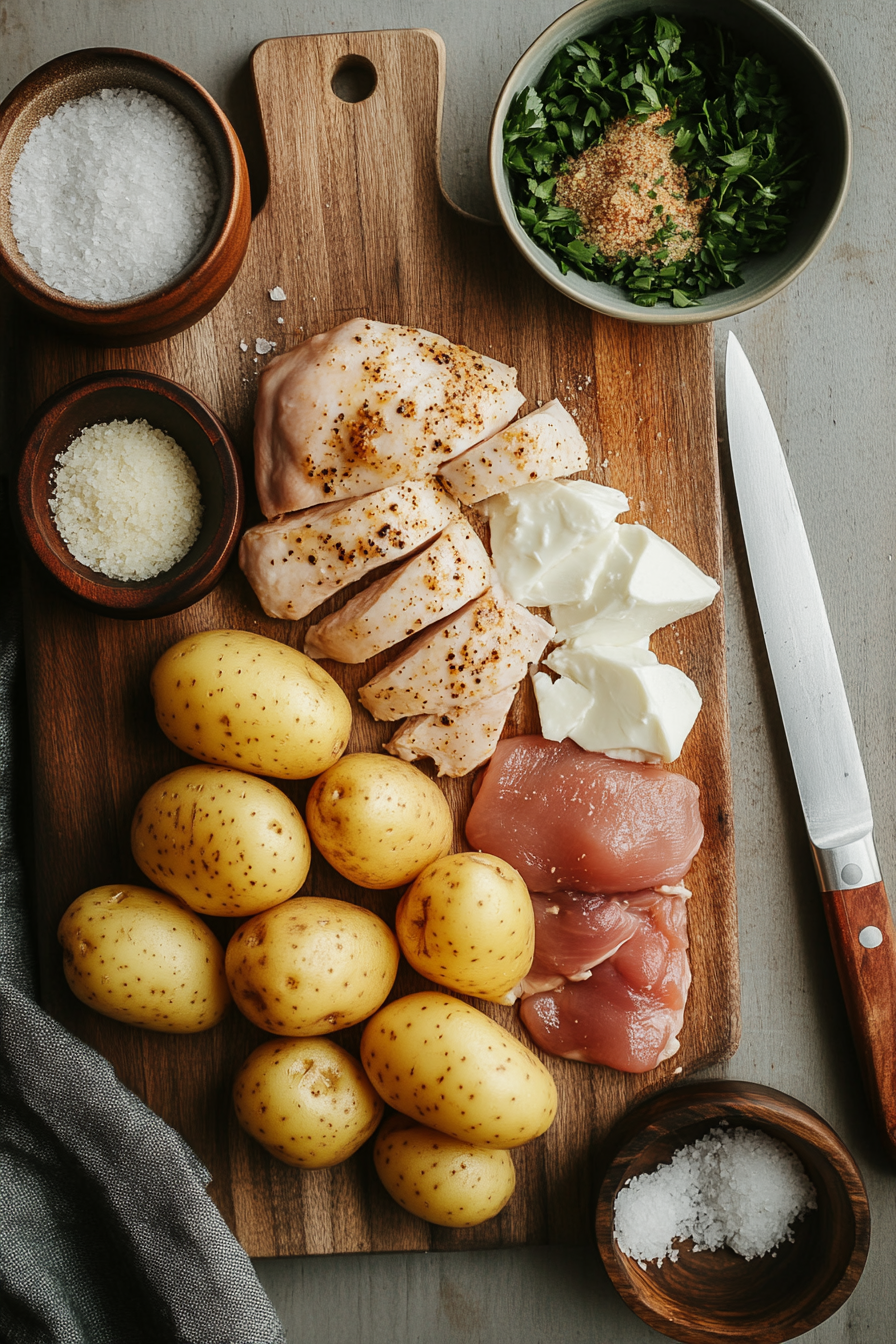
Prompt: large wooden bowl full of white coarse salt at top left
<box><xmin>0</xmin><ymin>47</ymin><xmax>251</xmax><ymax>345</ymax></box>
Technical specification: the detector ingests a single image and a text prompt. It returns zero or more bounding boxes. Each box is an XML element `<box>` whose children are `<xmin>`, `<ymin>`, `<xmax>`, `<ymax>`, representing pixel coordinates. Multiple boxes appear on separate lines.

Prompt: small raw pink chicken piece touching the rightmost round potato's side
<box><xmin>523</xmin><ymin>891</ymin><xmax>653</xmax><ymax>995</ymax></box>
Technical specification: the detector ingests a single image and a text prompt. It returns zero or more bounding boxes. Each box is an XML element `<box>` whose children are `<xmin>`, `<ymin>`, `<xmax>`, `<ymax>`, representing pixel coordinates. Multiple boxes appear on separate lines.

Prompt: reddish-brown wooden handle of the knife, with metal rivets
<box><xmin>822</xmin><ymin>882</ymin><xmax>896</xmax><ymax>1157</ymax></box>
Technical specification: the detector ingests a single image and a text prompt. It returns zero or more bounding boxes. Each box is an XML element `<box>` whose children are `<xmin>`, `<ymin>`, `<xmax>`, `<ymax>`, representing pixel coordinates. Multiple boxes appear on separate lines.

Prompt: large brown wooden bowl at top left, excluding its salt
<box><xmin>0</xmin><ymin>47</ymin><xmax>251</xmax><ymax>345</ymax></box>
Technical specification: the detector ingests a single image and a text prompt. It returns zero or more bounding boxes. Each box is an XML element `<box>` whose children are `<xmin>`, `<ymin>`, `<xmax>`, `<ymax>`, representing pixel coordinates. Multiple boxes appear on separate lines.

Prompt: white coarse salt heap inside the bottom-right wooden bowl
<box><xmin>614</xmin><ymin>1126</ymin><xmax>817</xmax><ymax>1269</ymax></box>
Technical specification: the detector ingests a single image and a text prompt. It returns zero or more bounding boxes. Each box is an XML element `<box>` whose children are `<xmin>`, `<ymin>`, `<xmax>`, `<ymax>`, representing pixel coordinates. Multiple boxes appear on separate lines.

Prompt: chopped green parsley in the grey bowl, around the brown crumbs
<box><xmin>504</xmin><ymin>12</ymin><xmax>807</xmax><ymax>308</ymax></box>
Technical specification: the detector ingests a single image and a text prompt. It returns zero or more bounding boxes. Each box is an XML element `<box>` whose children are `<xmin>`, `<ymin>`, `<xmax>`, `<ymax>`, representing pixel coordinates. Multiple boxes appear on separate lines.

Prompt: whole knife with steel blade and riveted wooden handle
<box><xmin>725</xmin><ymin>335</ymin><xmax>896</xmax><ymax>1156</ymax></box>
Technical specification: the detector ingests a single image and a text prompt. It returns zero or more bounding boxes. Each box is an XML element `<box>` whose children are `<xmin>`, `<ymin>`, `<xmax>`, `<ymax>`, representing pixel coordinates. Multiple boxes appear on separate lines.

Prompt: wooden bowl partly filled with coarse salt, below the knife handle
<box><xmin>596</xmin><ymin>1079</ymin><xmax>870</xmax><ymax>1344</ymax></box>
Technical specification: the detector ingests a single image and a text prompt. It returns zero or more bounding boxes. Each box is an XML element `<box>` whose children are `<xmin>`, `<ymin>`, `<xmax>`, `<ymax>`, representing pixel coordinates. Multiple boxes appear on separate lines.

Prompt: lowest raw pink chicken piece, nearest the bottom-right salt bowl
<box><xmin>520</xmin><ymin>891</ymin><xmax>690</xmax><ymax>1074</ymax></box>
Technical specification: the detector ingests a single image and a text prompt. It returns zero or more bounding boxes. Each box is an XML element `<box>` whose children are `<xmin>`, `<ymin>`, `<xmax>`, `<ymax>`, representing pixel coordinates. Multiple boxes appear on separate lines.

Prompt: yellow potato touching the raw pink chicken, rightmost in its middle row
<box><xmin>395</xmin><ymin>853</ymin><xmax>535</xmax><ymax>1003</ymax></box>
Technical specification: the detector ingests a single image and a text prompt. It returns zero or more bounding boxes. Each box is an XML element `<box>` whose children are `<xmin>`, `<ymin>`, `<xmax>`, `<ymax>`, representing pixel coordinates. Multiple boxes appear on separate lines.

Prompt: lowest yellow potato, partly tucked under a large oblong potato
<box><xmin>373</xmin><ymin>1116</ymin><xmax>516</xmax><ymax>1227</ymax></box>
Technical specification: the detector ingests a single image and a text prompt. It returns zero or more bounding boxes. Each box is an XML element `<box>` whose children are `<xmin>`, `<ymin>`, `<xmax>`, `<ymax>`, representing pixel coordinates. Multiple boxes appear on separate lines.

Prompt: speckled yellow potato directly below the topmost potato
<box><xmin>130</xmin><ymin>765</ymin><xmax>312</xmax><ymax>917</ymax></box>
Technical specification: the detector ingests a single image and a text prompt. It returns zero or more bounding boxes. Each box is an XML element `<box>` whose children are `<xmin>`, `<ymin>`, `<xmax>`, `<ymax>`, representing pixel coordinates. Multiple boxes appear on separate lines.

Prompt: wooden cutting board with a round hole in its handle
<box><xmin>19</xmin><ymin>31</ymin><xmax>739</xmax><ymax>1255</ymax></box>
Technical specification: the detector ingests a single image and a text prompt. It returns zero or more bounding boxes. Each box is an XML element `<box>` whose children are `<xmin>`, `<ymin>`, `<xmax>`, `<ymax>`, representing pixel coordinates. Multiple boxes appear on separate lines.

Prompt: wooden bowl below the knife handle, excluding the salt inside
<box><xmin>596</xmin><ymin>1081</ymin><xmax>870</xmax><ymax>1344</ymax></box>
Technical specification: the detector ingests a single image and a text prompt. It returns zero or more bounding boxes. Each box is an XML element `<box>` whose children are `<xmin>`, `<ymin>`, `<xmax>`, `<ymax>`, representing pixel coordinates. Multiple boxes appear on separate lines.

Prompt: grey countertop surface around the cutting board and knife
<box><xmin>0</xmin><ymin>0</ymin><xmax>896</xmax><ymax>1344</ymax></box>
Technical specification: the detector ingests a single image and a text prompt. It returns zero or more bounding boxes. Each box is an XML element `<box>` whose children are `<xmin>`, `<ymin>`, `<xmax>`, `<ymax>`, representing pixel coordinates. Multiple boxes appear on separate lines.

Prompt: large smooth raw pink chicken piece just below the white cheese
<box><xmin>466</xmin><ymin>737</ymin><xmax>703</xmax><ymax>895</ymax></box>
